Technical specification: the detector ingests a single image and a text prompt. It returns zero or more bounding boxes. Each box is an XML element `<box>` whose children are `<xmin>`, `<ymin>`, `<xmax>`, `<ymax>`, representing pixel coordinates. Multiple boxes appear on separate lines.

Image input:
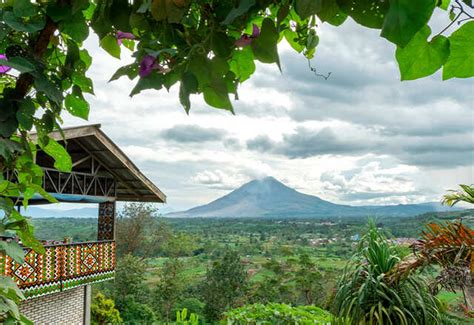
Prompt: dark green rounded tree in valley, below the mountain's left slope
<box><xmin>202</xmin><ymin>251</ymin><xmax>248</xmax><ymax>321</ymax></box>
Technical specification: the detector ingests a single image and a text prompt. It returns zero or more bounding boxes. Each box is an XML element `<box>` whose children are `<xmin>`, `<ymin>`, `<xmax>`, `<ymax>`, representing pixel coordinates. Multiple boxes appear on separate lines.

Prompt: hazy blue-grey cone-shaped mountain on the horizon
<box><xmin>168</xmin><ymin>176</ymin><xmax>460</xmax><ymax>218</ymax></box>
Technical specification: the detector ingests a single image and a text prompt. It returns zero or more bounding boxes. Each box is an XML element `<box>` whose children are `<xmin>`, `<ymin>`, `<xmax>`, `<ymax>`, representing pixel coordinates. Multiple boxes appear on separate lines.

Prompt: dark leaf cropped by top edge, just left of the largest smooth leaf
<box><xmin>337</xmin><ymin>0</ymin><xmax>389</xmax><ymax>28</ymax></box>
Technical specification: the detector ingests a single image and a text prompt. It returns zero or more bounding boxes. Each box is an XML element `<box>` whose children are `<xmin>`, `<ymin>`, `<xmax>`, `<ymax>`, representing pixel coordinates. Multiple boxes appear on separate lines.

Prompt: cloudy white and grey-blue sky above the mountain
<box><xmin>61</xmin><ymin>10</ymin><xmax>474</xmax><ymax>210</ymax></box>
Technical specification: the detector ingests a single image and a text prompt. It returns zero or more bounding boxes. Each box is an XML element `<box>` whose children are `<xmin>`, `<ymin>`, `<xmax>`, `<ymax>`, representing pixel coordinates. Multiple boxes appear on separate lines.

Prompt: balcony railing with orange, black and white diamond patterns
<box><xmin>0</xmin><ymin>241</ymin><xmax>115</xmax><ymax>299</ymax></box>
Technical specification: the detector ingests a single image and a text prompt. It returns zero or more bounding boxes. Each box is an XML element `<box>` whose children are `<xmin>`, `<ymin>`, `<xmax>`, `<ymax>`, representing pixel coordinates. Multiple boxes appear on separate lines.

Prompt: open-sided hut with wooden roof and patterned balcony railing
<box><xmin>0</xmin><ymin>124</ymin><xmax>166</xmax><ymax>324</ymax></box>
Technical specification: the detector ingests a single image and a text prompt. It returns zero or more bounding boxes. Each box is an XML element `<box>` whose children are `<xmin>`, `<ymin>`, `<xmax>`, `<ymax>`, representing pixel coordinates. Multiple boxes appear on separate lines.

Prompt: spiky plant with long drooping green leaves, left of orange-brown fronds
<box><xmin>334</xmin><ymin>223</ymin><xmax>441</xmax><ymax>325</ymax></box>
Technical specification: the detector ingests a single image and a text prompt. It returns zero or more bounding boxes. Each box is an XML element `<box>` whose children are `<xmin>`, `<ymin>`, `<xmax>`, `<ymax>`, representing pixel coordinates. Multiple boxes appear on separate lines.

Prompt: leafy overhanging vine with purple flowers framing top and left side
<box><xmin>0</xmin><ymin>0</ymin><xmax>474</xmax><ymax>320</ymax></box>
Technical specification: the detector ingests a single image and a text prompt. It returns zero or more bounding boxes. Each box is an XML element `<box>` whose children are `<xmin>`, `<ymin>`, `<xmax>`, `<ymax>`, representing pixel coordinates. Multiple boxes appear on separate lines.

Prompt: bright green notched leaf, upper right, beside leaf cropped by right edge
<box><xmin>395</xmin><ymin>26</ymin><xmax>449</xmax><ymax>80</ymax></box>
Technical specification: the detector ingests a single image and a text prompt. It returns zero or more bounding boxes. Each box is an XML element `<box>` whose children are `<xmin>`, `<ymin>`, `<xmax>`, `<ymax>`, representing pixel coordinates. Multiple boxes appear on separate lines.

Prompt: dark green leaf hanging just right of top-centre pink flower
<box><xmin>252</xmin><ymin>18</ymin><xmax>280</xmax><ymax>66</ymax></box>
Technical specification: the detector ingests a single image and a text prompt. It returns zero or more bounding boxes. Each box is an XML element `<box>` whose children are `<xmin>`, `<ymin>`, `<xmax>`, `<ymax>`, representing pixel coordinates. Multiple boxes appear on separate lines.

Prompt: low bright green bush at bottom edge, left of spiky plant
<box><xmin>222</xmin><ymin>303</ymin><xmax>334</xmax><ymax>325</ymax></box>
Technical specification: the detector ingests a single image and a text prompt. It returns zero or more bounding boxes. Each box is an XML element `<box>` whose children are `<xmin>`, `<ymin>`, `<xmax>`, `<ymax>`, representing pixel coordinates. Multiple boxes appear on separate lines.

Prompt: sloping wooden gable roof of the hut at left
<box><xmin>32</xmin><ymin>124</ymin><xmax>166</xmax><ymax>203</ymax></box>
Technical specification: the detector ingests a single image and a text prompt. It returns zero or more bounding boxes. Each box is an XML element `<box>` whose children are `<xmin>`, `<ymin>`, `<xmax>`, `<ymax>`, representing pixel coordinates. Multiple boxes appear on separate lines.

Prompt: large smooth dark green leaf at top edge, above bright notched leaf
<box><xmin>381</xmin><ymin>0</ymin><xmax>436</xmax><ymax>47</ymax></box>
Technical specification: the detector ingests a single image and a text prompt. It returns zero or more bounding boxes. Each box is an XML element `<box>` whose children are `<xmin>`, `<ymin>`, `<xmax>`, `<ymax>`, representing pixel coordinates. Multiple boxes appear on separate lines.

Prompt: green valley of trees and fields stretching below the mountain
<box><xmin>33</xmin><ymin>204</ymin><xmax>474</xmax><ymax>324</ymax></box>
